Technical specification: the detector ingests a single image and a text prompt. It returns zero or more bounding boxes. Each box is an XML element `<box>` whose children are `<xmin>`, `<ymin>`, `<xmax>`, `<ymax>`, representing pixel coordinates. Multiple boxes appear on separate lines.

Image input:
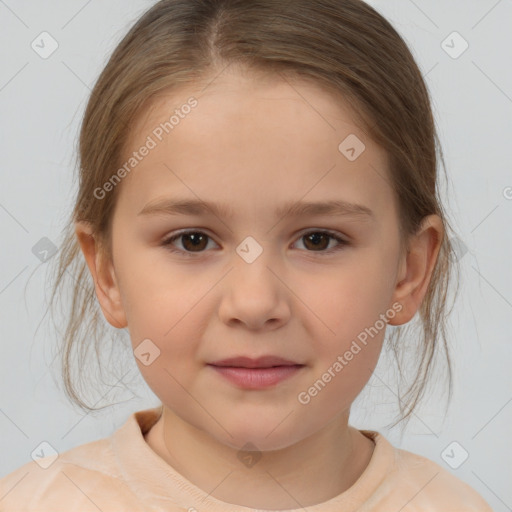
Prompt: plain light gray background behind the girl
<box><xmin>0</xmin><ymin>0</ymin><xmax>512</xmax><ymax>512</ymax></box>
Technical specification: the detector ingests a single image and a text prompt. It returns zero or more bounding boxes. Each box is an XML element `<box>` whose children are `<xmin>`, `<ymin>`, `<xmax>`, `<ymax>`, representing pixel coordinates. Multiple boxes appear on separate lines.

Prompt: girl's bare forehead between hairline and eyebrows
<box><xmin>115</xmin><ymin>68</ymin><xmax>392</xmax><ymax>218</ymax></box>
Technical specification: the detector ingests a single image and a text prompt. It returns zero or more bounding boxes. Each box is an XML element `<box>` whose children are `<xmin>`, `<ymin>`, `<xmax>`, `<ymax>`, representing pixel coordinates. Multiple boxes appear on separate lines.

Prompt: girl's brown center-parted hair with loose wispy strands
<box><xmin>44</xmin><ymin>0</ymin><xmax>458</xmax><ymax>430</ymax></box>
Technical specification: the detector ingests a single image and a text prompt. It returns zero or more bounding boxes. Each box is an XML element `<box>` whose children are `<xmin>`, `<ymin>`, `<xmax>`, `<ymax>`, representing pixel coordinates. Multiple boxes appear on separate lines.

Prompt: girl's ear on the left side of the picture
<box><xmin>75</xmin><ymin>221</ymin><xmax>128</xmax><ymax>329</ymax></box>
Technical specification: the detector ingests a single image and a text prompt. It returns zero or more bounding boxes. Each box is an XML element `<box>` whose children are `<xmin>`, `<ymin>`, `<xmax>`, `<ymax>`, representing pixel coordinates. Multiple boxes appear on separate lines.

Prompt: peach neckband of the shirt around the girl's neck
<box><xmin>111</xmin><ymin>406</ymin><xmax>394</xmax><ymax>512</ymax></box>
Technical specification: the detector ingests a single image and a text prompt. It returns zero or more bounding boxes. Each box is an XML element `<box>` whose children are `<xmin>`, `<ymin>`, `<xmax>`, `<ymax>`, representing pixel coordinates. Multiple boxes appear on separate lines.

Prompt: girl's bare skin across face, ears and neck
<box><xmin>76</xmin><ymin>67</ymin><xmax>443</xmax><ymax>510</ymax></box>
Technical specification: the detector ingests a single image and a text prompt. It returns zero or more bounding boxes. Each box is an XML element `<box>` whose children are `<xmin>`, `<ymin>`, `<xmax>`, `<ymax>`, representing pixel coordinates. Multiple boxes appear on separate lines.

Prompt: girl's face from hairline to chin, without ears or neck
<box><xmin>96</xmin><ymin>72</ymin><xmax>408</xmax><ymax>449</ymax></box>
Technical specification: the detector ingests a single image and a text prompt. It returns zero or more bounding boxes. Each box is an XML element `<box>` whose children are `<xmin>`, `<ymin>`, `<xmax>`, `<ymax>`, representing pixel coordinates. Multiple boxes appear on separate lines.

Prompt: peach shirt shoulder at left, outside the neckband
<box><xmin>0</xmin><ymin>438</ymin><xmax>142</xmax><ymax>512</ymax></box>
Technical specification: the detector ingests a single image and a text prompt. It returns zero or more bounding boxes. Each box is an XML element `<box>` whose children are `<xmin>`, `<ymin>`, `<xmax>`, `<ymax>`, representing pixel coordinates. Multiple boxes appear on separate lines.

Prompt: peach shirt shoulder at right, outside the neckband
<box><xmin>370</xmin><ymin>434</ymin><xmax>492</xmax><ymax>512</ymax></box>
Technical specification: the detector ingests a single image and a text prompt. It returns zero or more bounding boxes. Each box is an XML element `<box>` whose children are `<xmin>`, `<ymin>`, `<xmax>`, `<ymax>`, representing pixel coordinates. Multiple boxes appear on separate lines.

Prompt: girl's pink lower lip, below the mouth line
<box><xmin>209</xmin><ymin>365</ymin><xmax>303</xmax><ymax>389</ymax></box>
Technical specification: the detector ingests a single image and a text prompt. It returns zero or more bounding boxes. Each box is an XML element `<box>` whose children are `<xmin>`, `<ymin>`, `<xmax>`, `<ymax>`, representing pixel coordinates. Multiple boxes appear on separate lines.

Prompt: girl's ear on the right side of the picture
<box><xmin>388</xmin><ymin>215</ymin><xmax>444</xmax><ymax>325</ymax></box>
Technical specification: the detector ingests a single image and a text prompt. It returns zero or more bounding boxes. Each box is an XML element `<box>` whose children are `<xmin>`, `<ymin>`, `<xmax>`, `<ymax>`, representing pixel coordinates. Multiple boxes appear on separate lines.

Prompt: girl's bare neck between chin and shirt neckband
<box><xmin>142</xmin><ymin>406</ymin><xmax>374</xmax><ymax>510</ymax></box>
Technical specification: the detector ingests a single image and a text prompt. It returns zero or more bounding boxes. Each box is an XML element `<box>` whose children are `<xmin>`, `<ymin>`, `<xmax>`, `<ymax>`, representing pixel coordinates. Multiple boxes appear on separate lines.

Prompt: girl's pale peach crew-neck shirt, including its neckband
<box><xmin>0</xmin><ymin>407</ymin><xmax>492</xmax><ymax>512</ymax></box>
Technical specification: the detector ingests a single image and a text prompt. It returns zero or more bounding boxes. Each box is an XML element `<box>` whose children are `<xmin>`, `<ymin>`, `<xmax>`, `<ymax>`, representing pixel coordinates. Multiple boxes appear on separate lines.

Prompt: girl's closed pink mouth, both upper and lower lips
<box><xmin>208</xmin><ymin>356</ymin><xmax>305</xmax><ymax>390</ymax></box>
